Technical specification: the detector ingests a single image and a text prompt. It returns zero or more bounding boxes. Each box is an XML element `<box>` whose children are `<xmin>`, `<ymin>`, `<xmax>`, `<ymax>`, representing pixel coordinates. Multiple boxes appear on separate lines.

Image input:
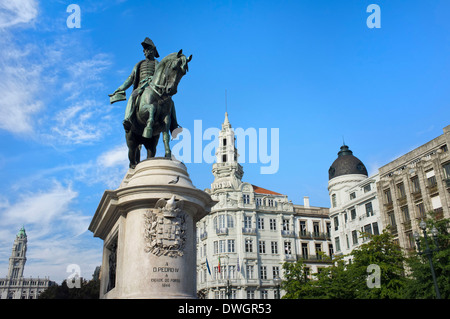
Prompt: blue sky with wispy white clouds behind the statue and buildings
<box><xmin>0</xmin><ymin>0</ymin><xmax>450</xmax><ymax>282</ymax></box>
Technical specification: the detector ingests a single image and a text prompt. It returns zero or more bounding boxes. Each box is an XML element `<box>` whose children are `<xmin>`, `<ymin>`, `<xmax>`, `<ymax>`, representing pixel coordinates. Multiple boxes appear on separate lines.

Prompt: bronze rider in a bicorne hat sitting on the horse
<box><xmin>113</xmin><ymin>38</ymin><xmax>159</xmax><ymax>133</ymax></box>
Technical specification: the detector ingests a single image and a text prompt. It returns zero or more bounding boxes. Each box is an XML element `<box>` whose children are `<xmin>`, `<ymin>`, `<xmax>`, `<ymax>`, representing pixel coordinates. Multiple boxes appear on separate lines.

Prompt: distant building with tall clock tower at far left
<box><xmin>0</xmin><ymin>227</ymin><xmax>54</xmax><ymax>299</ymax></box>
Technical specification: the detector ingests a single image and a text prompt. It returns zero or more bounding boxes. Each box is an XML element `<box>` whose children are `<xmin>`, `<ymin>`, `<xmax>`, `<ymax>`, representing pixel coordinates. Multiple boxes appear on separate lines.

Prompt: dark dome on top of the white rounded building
<box><xmin>328</xmin><ymin>145</ymin><xmax>368</xmax><ymax>180</ymax></box>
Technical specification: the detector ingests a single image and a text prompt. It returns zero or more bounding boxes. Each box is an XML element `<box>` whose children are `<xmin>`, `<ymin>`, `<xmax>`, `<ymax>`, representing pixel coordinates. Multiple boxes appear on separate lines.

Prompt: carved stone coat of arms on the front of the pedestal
<box><xmin>144</xmin><ymin>196</ymin><xmax>186</xmax><ymax>257</ymax></box>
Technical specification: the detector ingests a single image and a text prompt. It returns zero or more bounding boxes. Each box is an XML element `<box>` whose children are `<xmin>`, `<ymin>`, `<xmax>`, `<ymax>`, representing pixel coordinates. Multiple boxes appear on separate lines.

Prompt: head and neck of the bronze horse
<box><xmin>153</xmin><ymin>50</ymin><xmax>192</xmax><ymax>95</ymax></box>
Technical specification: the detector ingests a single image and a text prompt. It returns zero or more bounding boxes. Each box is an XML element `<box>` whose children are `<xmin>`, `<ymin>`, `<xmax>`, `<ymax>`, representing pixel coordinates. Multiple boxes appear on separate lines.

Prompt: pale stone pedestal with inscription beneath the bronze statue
<box><xmin>89</xmin><ymin>158</ymin><xmax>215</xmax><ymax>299</ymax></box>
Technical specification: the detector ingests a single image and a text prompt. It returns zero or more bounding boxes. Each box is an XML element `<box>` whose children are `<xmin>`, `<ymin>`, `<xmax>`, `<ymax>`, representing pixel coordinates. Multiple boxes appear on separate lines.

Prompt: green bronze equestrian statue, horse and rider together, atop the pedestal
<box><xmin>110</xmin><ymin>38</ymin><xmax>192</xmax><ymax>168</ymax></box>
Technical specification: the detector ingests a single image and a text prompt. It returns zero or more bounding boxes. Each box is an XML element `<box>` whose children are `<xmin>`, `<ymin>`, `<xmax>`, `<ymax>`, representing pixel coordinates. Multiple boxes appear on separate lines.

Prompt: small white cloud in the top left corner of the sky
<box><xmin>0</xmin><ymin>0</ymin><xmax>38</xmax><ymax>29</ymax></box>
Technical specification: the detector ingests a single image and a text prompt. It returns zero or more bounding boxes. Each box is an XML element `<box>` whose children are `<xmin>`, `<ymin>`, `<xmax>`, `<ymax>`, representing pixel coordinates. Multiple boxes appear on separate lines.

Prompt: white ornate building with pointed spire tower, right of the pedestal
<box><xmin>197</xmin><ymin>113</ymin><xmax>333</xmax><ymax>299</ymax></box>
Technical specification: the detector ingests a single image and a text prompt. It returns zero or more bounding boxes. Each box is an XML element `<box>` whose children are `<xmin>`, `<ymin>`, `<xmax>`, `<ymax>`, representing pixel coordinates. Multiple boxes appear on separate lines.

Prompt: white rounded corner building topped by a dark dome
<box><xmin>328</xmin><ymin>145</ymin><xmax>384</xmax><ymax>260</ymax></box>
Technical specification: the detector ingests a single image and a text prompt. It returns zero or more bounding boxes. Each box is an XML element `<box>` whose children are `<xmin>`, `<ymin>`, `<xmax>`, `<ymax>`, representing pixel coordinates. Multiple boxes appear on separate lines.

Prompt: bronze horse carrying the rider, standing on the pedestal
<box><xmin>125</xmin><ymin>50</ymin><xmax>192</xmax><ymax>168</ymax></box>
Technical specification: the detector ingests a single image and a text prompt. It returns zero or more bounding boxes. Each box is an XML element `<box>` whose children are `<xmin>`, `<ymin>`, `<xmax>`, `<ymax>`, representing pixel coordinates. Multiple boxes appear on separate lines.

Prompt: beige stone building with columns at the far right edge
<box><xmin>377</xmin><ymin>125</ymin><xmax>450</xmax><ymax>249</ymax></box>
